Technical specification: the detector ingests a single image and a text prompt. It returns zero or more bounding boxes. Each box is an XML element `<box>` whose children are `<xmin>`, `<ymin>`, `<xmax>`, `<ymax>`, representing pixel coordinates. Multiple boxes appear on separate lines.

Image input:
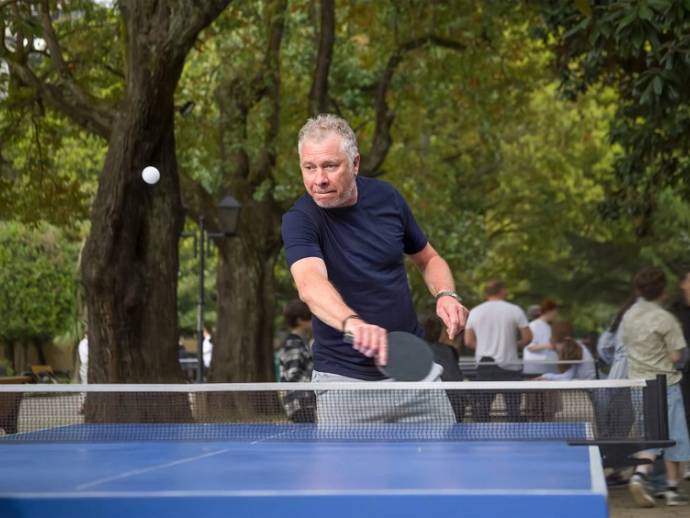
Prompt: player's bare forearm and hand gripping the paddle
<box><xmin>290</xmin><ymin>257</ymin><xmax>388</xmax><ymax>365</ymax></box>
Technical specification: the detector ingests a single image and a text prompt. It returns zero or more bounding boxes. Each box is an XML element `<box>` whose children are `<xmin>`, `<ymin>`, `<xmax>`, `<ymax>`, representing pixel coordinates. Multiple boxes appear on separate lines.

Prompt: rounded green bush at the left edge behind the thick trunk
<box><xmin>0</xmin><ymin>223</ymin><xmax>79</xmax><ymax>342</ymax></box>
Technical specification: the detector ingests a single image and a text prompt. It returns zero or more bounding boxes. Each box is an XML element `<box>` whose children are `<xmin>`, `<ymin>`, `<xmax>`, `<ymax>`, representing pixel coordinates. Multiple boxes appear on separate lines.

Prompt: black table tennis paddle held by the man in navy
<box><xmin>344</xmin><ymin>331</ymin><xmax>440</xmax><ymax>381</ymax></box>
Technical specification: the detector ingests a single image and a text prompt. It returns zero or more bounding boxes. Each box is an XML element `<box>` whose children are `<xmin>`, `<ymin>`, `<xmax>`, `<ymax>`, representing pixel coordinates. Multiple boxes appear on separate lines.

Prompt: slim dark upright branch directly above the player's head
<box><xmin>309</xmin><ymin>0</ymin><xmax>335</xmax><ymax>117</ymax></box>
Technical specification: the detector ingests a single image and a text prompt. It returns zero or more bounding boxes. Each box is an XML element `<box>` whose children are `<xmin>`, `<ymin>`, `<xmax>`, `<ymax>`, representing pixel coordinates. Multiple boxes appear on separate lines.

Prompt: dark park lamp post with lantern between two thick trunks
<box><xmin>185</xmin><ymin>195</ymin><xmax>242</xmax><ymax>383</ymax></box>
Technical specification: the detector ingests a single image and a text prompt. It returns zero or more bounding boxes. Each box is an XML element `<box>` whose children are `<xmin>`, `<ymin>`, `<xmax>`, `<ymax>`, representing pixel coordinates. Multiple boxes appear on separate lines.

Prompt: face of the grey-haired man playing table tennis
<box><xmin>300</xmin><ymin>134</ymin><xmax>359</xmax><ymax>209</ymax></box>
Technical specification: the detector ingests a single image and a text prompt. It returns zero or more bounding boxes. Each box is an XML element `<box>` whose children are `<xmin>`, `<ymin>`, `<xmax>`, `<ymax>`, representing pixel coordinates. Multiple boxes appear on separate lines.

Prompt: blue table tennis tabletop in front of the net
<box><xmin>0</xmin><ymin>423</ymin><xmax>608</xmax><ymax>518</ymax></box>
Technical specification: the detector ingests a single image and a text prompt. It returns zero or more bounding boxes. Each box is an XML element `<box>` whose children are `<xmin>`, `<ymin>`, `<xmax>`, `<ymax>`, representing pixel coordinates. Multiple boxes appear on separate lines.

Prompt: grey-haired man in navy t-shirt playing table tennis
<box><xmin>282</xmin><ymin>114</ymin><xmax>467</xmax><ymax>422</ymax></box>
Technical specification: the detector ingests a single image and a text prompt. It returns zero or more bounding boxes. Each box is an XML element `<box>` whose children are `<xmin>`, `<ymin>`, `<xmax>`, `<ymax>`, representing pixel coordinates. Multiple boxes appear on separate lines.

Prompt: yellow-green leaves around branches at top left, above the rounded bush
<box><xmin>0</xmin><ymin>0</ymin><xmax>114</xmax><ymax>228</ymax></box>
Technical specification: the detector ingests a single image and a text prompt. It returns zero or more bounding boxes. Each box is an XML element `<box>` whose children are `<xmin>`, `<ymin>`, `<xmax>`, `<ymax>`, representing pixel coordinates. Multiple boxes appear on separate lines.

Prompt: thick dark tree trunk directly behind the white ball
<box><xmin>77</xmin><ymin>0</ymin><xmax>228</xmax><ymax>422</ymax></box>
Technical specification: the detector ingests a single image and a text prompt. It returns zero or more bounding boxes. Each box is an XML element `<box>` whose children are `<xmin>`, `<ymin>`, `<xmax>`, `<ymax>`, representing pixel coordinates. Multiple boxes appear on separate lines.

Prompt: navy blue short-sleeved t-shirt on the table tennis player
<box><xmin>282</xmin><ymin>176</ymin><xmax>427</xmax><ymax>380</ymax></box>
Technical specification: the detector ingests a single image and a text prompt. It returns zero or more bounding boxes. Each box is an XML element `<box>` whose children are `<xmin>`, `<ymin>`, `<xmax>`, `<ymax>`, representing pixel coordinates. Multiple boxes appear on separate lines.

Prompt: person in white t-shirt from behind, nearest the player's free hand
<box><xmin>465</xmin><ymin>280</ymin><xmax>532</xmax><ymax>421</ymax></box>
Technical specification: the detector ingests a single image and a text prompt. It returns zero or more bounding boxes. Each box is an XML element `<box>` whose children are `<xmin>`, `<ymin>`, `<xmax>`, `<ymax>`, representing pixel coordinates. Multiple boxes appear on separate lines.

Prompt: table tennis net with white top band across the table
<box><xmin>0</xmin><ymin>380</ymin><xmax>665</xmax><ymax>442</ymax></box>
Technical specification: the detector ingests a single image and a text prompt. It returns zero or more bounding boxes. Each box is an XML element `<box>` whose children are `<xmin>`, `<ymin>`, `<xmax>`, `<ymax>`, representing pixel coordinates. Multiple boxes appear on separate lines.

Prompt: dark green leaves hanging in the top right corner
<box><xmin>537</xmin><ymin>0</ymin><xmax>690</xmax><ymax>236</ymax></box>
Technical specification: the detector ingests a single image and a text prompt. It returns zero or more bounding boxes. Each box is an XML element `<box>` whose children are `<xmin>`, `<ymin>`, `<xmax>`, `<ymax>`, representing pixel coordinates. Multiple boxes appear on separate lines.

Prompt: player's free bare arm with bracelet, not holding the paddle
<box><xmin>410</xmin><ymin>243</ymin><xmax>468</xmax><ymax>339</ymax></box>
